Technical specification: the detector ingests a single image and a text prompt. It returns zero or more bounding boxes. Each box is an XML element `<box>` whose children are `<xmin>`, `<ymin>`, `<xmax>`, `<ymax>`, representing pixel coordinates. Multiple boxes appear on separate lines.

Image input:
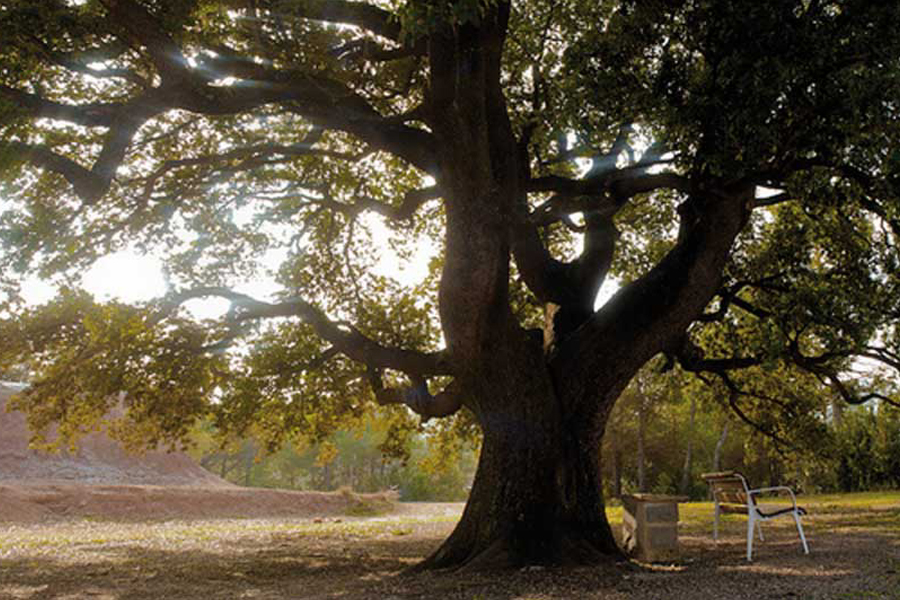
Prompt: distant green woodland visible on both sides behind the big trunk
<box><xmin>193</xmin><ymin>364</ymin><xmax>900</xmax><ymax>502</ymax></box>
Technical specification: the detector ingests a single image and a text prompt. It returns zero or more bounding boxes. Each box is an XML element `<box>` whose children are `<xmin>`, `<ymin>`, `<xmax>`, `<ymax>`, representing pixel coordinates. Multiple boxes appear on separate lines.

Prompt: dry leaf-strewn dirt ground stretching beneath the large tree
<box><xmin>0</xmin><ymin>486</ymin><xmax>900</xmax><ymax>600</ymax></box>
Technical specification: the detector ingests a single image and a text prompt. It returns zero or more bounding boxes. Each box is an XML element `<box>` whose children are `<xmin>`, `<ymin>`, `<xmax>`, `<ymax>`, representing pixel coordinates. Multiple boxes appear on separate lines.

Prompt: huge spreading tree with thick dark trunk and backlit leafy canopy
<box><xmin>0</xmin><ymin>0</ymin><xmax>900</xmax><ymax>568</ymax></box>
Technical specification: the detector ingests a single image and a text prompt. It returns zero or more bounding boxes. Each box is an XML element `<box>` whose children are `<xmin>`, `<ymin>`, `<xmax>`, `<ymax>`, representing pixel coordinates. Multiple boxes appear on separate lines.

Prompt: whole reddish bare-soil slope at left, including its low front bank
<box><xmin>0</xmin><ymin>382</ymin><xmax>394</xmax><ymax>523</ymax></box>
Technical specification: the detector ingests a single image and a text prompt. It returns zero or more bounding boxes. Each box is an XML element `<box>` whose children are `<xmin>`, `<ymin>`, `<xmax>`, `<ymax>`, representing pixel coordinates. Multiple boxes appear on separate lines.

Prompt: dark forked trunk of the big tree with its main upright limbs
<box><xmin>418</xmin><ymin>2</ymin><xmax>753</xmax><ymax>569</ymax></box>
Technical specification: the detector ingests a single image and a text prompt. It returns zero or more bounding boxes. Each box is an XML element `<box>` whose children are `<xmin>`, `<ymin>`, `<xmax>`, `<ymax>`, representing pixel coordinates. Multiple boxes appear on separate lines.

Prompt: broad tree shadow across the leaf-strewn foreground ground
<box><xmin>0</xmin><ymin>513</ymin><xmax>900</xmax><ymax>600</ymax></box>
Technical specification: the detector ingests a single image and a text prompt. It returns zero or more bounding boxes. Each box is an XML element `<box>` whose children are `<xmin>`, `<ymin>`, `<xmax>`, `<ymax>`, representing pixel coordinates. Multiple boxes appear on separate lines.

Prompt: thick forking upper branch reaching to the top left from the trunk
<box><xmin>8</xmin><ymin>9</ymin><xmax>438</xmax><ymax>207</ymax></box>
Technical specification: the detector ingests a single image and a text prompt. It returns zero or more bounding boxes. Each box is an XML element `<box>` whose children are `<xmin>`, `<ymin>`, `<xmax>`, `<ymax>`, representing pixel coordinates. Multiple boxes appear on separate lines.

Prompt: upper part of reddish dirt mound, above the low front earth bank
<box><xmin>0</xmin><ymin>382</ymin><xmax>232</xmax><ymax>490</ymax></box>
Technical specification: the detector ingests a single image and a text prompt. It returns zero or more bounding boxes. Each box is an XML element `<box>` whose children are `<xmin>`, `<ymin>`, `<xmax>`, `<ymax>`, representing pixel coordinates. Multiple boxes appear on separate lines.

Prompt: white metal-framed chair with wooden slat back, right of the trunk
<box><xmin>701</xmin><ymin>471</ymin><xmax>809</xmax><ymax>561</ymax></box>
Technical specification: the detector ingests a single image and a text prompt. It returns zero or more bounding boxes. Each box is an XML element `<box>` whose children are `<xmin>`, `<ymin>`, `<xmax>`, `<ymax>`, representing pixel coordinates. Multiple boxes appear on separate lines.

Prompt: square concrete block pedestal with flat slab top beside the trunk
<box><xmin>622</xmin><ymin>494</ymin><xmax>688</xmax><ymax>562</ymax></box>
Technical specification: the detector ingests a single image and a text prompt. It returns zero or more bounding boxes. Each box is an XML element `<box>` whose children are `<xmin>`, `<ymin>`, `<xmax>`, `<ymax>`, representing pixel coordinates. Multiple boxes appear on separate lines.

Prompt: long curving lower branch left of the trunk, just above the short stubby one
<box><xmin>157</xmin><ymin>287</ymin><xmax>450</xmax><ymax>377</ymax></box>
